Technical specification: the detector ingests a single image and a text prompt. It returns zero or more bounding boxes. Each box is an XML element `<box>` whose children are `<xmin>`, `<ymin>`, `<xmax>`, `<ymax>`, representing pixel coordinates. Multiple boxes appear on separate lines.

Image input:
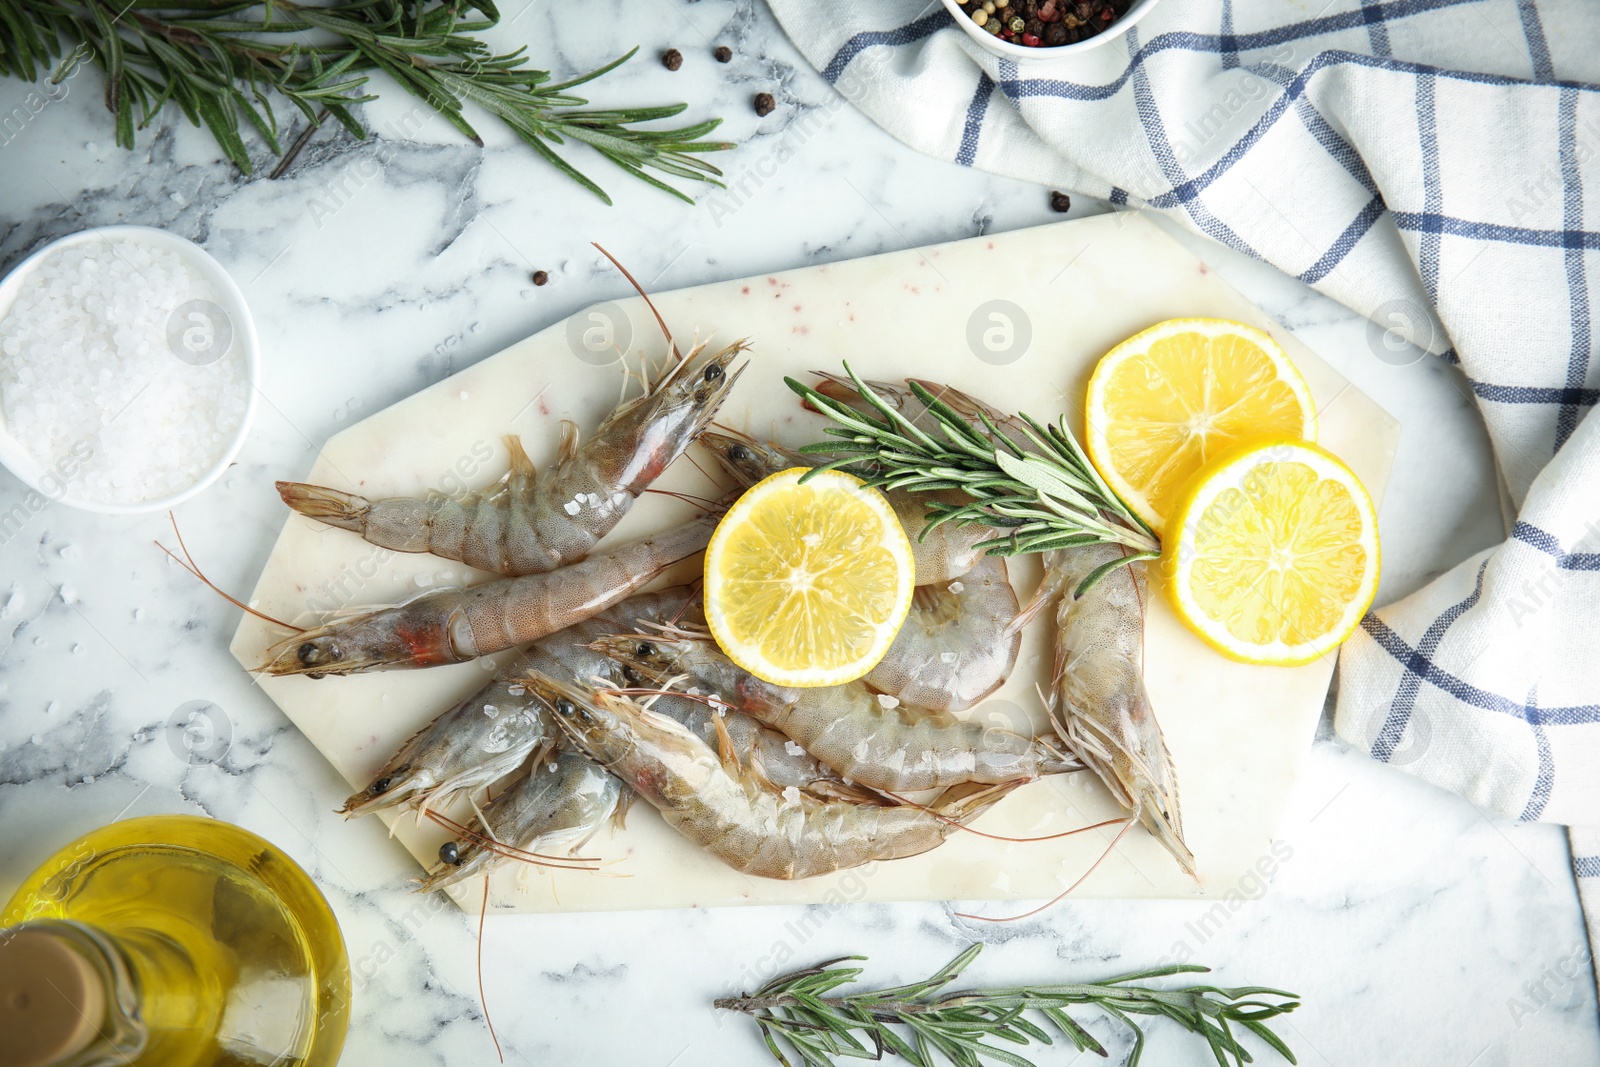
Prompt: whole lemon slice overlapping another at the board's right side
<box><xmin>1165</xmin><ymin>440</ymin><xmax>1379</xmax><ymax>667</ymax></box>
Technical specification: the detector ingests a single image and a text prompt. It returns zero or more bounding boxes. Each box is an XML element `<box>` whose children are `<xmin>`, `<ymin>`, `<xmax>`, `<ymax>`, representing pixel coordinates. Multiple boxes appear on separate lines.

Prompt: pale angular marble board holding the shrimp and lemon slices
<box><xmin>232</xmin><ymin>213</ymin><xmax>1400</xmax><ymax>915</ymax></box>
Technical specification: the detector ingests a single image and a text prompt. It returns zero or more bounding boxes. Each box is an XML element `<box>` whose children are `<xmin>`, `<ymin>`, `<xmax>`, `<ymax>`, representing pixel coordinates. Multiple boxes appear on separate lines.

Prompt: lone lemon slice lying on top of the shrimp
<box><xmin>706</xmin><ymin>467</ymin><xmax>917</xmax><ymax>688</ymax></box>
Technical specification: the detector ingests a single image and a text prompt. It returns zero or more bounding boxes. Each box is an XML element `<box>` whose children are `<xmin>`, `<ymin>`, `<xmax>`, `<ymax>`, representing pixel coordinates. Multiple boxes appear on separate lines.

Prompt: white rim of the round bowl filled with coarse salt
<box><xmin>0</xmin><ymin>226</ymin><xmax>261</xmax><ymax>515</ymax></box>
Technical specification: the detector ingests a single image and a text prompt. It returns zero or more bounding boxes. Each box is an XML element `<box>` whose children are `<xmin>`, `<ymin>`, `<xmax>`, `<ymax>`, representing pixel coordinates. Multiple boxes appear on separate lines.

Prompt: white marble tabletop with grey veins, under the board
<box><xmin>0</xmin><ymin>0</ymin><xmax>1600</xmax><ymax>1067</ymax></box>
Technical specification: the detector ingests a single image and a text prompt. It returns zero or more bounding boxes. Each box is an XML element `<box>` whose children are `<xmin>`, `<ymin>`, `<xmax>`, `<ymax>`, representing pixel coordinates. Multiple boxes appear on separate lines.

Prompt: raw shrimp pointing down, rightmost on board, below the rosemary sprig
<box><xmin>1035</xmin><ymin>545</ymin><xmax>1195</xmax><ymax>875</ymax></box>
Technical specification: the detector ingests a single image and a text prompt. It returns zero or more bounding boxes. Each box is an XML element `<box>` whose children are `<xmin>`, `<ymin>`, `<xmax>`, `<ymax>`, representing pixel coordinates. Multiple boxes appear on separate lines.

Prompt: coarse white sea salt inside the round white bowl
<box><xmin>0</xmin><ymin>238</ymin><xmax>250</xmax><ymax>504</ymax></box>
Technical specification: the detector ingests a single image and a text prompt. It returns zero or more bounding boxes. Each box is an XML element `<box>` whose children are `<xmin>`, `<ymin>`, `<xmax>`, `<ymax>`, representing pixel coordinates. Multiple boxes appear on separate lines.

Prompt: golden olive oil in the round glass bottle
<box><xmin>0</xmin><ymin>816</ymin><xmax>350</xmax><ymax>1067</ymax></box>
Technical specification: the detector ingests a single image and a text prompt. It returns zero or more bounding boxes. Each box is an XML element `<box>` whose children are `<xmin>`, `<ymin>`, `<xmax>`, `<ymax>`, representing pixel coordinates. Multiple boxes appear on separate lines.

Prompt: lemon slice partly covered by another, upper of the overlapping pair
<box><xmin>1085</xmin><ymin>318</ymin><xmax>1317</xmax><ymax>533</ymax></box>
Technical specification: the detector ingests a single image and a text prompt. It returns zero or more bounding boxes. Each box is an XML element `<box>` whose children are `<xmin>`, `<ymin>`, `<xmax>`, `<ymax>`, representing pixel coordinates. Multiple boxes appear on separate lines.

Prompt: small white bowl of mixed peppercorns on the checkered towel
<box><xmin>944</xmin><ymin>0</ymin><xmax>1155</xmax><ymax>59</ymax></box>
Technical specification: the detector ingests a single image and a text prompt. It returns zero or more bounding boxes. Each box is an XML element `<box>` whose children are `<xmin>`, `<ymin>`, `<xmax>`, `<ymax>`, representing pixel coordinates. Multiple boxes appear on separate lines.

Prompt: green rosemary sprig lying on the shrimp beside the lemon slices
<box><xmin>784</xmin><ymin>363</ymin><xmax>1162</xmax><ymax>595</ymax></box>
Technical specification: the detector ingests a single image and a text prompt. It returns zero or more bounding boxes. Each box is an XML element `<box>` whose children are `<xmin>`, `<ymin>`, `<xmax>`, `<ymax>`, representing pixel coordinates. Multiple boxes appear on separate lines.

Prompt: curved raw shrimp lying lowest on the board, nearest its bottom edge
<box><xmin>528</xmin><ymin>675</ymin><xmax>1014</xmax><ymax>878</ymax></box>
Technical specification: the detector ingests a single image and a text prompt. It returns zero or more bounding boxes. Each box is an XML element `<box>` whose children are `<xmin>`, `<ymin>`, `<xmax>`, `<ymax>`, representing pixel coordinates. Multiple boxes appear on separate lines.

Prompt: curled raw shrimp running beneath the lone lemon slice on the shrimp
<box><xmin>701</xmin><ymin>430</ymin><xmax>1022</xmax><ymax>712</ymax></box>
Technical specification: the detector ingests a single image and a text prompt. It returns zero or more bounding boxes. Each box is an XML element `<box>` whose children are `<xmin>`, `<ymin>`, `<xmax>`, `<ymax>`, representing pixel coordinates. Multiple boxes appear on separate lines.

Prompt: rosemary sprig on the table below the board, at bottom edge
<box><xmin>715</xmin><ymin>944</ymin><xmax>1299</xmax><ymax>1067</ymax></box>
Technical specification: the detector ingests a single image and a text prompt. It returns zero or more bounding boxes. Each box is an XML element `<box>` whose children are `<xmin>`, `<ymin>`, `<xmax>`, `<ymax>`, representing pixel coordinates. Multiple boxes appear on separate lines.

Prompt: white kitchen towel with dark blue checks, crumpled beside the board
<box><xmin>771</xmin><ymin>0</ymin><xmax>1600</xmax><ymax>985</ymax></box>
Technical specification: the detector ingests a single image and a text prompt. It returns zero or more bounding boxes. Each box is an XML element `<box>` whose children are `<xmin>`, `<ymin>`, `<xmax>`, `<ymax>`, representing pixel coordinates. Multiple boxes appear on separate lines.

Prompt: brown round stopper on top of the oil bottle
<box><xmin>0</xmin><ymin>928</ymin><xmax>106</xmax><ymax>1067</ymax></box>
